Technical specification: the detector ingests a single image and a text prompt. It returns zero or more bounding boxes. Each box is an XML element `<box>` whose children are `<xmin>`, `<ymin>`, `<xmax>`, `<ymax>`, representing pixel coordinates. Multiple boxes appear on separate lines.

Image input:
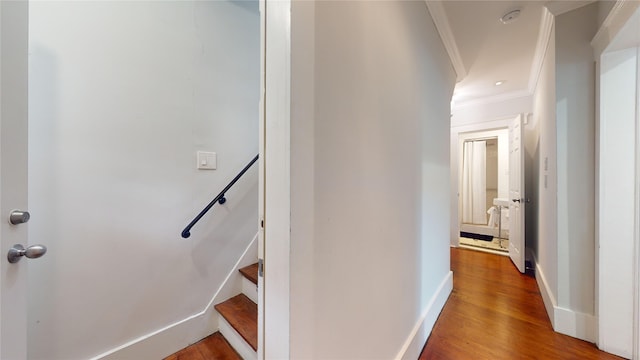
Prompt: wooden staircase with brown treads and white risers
<box><xmin>165</xmin><ymin>264</ymin><xmax>258</xmax><ymax>360</ymax></box>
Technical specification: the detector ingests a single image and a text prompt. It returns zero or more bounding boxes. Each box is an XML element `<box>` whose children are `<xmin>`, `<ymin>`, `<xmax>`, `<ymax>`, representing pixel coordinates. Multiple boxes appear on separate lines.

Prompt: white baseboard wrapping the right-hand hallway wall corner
<box><xmin>536</xmin><ymin>261</ymin><xmax>596</xmax><ymax>343</ymax></box>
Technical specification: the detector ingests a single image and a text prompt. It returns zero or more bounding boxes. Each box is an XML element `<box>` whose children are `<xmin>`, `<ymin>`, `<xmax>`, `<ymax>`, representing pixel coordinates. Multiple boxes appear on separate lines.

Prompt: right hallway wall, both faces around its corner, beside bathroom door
<box><xmin>532</xmin><ymin>4</ymin><xmax>598</xmax><ymax>342</ymax></box>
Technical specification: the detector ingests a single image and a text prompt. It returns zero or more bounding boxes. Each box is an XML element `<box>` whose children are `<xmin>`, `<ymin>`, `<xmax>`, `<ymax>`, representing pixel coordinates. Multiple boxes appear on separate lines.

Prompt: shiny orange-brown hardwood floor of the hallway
<box><xmin>420</xmin><ymin>248</ymin><xmax>621</xmax><ymax>360</ymax></box>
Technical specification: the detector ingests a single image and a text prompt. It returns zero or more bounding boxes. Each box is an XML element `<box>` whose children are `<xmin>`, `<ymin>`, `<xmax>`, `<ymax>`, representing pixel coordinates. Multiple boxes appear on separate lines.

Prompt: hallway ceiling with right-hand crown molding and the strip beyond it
<box><xmin>427</xmin><ymin>0</ymin><xmax>593</xmax><ymax>106</ymax></box>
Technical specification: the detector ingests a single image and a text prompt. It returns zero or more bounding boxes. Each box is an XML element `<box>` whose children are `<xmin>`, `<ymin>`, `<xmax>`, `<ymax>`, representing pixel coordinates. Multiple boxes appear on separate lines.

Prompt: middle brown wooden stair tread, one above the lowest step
<box><xmin>215</xmin><ymin>294</ymin><xmax>258</xmax><ymax>350</ymax></box>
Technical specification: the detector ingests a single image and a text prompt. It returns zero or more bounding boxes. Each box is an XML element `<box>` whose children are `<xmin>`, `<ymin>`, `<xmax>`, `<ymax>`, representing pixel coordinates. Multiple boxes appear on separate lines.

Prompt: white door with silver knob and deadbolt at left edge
<box><xmin>0</xmin><ymin>1</ymin><xmax>29</xmax><ymax>359</ymax></box>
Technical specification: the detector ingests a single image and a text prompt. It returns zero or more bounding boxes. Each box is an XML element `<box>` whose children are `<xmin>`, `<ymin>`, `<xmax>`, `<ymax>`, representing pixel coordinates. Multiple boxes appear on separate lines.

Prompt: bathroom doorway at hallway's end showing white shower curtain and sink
<box><xmin>458</xmin><ymin>128</ymin><xmax>509</xmax><ymax>255</ymax></box>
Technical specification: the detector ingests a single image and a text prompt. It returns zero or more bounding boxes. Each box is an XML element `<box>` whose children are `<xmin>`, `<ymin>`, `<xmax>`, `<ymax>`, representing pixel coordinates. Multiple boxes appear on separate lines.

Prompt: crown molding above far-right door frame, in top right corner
<box><xmin>591</xmin><ymin>0</ymin><xmax>640</xmax><ymax>59</ymax></box>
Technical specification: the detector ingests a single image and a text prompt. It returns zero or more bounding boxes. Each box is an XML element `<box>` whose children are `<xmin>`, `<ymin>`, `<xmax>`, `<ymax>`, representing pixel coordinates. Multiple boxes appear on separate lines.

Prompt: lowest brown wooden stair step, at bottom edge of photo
<box><xmin>165</xmin><ymin>331</ymin><xmax>242</xmax><ymax>360</ymax></box>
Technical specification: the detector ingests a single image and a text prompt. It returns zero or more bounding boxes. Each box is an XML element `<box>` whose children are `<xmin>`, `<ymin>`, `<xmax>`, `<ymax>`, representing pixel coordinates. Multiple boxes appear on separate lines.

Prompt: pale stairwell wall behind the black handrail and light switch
<box><xmin>29</xmin><ymin>1</ymin><xmax>259</xmax><ymax>359</ymax></box>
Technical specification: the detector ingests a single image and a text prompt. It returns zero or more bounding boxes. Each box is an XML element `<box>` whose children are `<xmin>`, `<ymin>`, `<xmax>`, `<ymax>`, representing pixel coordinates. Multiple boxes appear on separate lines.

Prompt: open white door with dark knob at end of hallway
<box><xmin>509</xmin><ymin>115</ymin><xmax>525</xmax><ymax>273</ymax></box>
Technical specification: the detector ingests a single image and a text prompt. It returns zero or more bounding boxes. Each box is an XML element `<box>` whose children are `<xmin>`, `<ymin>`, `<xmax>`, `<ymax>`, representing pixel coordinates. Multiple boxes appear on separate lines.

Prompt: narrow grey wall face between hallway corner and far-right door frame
<box><xmin>555</xmin><ymin>4</ymin><xmax>598</xmax><ymax>334</ymax></box>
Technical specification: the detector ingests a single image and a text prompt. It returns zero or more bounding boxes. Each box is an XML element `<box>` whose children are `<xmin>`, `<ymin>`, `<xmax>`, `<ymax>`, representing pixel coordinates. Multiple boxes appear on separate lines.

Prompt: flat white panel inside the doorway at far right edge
<box><xmin>598</xmin><ymin>44</ymin><xmax>638</xmax><ymax>358</ymax></box>
